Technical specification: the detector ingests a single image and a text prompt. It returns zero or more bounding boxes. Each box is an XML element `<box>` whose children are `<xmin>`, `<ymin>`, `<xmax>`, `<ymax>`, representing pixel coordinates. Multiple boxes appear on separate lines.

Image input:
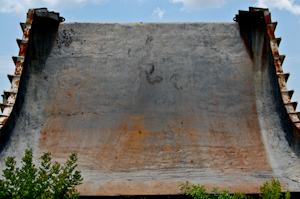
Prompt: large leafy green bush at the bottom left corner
<box><xmin>0</xmin><ymin>150</ymin><xmax>83</xmax><ymax>199</ymax></box>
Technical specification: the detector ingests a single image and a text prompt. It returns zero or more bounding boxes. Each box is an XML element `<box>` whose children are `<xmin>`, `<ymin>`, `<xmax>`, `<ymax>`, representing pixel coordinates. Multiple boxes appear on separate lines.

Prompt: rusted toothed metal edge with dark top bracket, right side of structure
<box><xmin>234</xmin><ymin>7</ymin><xmax>300</xmax><ymax>129</ymax></box>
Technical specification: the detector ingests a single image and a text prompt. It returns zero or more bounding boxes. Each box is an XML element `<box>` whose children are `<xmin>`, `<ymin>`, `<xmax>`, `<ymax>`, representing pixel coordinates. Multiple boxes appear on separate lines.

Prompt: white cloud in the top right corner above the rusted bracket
<box><xmin>256</xmin><ymin>0</ymin><xmax>300</xmax><ymax>15</ymax></box>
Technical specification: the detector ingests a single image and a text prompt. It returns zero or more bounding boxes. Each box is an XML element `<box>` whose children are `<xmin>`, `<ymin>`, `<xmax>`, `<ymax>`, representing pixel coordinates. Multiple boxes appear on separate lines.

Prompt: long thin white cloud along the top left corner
<box><xmin>0</xmin><ymin>0</ymin><xmax>109</xmax><ymax>13</ymax></box>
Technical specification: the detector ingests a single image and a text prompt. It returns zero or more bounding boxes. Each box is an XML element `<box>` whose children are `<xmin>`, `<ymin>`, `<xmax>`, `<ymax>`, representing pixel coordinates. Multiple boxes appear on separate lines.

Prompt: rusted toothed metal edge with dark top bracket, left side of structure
<box><xmin>0</xmin><ymin>8</ymin><xmax>64</xmax><ymax>129</ymax></box>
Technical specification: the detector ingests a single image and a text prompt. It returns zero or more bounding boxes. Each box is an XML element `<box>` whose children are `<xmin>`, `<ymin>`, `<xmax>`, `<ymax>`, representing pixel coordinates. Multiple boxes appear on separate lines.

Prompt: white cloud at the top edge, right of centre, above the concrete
<box><xmin>170</xmin><ymin>0</ymin><xmax>226</xmax><ymax>11</ymax></box>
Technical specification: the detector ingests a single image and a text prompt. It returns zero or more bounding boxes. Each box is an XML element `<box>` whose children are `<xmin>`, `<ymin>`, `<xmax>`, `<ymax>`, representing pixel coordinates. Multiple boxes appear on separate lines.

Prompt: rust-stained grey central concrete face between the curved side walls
<box><xmin>39</xmin><ymin>23</ymin><xmax>272</xmax><ymax>194</ymax></box>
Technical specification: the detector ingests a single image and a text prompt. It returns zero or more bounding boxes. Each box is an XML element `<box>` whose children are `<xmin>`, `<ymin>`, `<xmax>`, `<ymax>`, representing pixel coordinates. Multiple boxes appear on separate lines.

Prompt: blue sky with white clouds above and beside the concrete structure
<box><xmin>0</xmin><ymin>0</ymin><xmax>300</xmax><ymax>110</ymax></box>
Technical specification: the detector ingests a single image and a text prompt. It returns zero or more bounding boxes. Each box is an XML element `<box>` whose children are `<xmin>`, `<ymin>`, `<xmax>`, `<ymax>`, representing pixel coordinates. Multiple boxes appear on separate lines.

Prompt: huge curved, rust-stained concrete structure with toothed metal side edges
<box><xmin>0</xmin><ymin>8</ymin><xmax>300</xmax><ymax>195</ymax></box>
